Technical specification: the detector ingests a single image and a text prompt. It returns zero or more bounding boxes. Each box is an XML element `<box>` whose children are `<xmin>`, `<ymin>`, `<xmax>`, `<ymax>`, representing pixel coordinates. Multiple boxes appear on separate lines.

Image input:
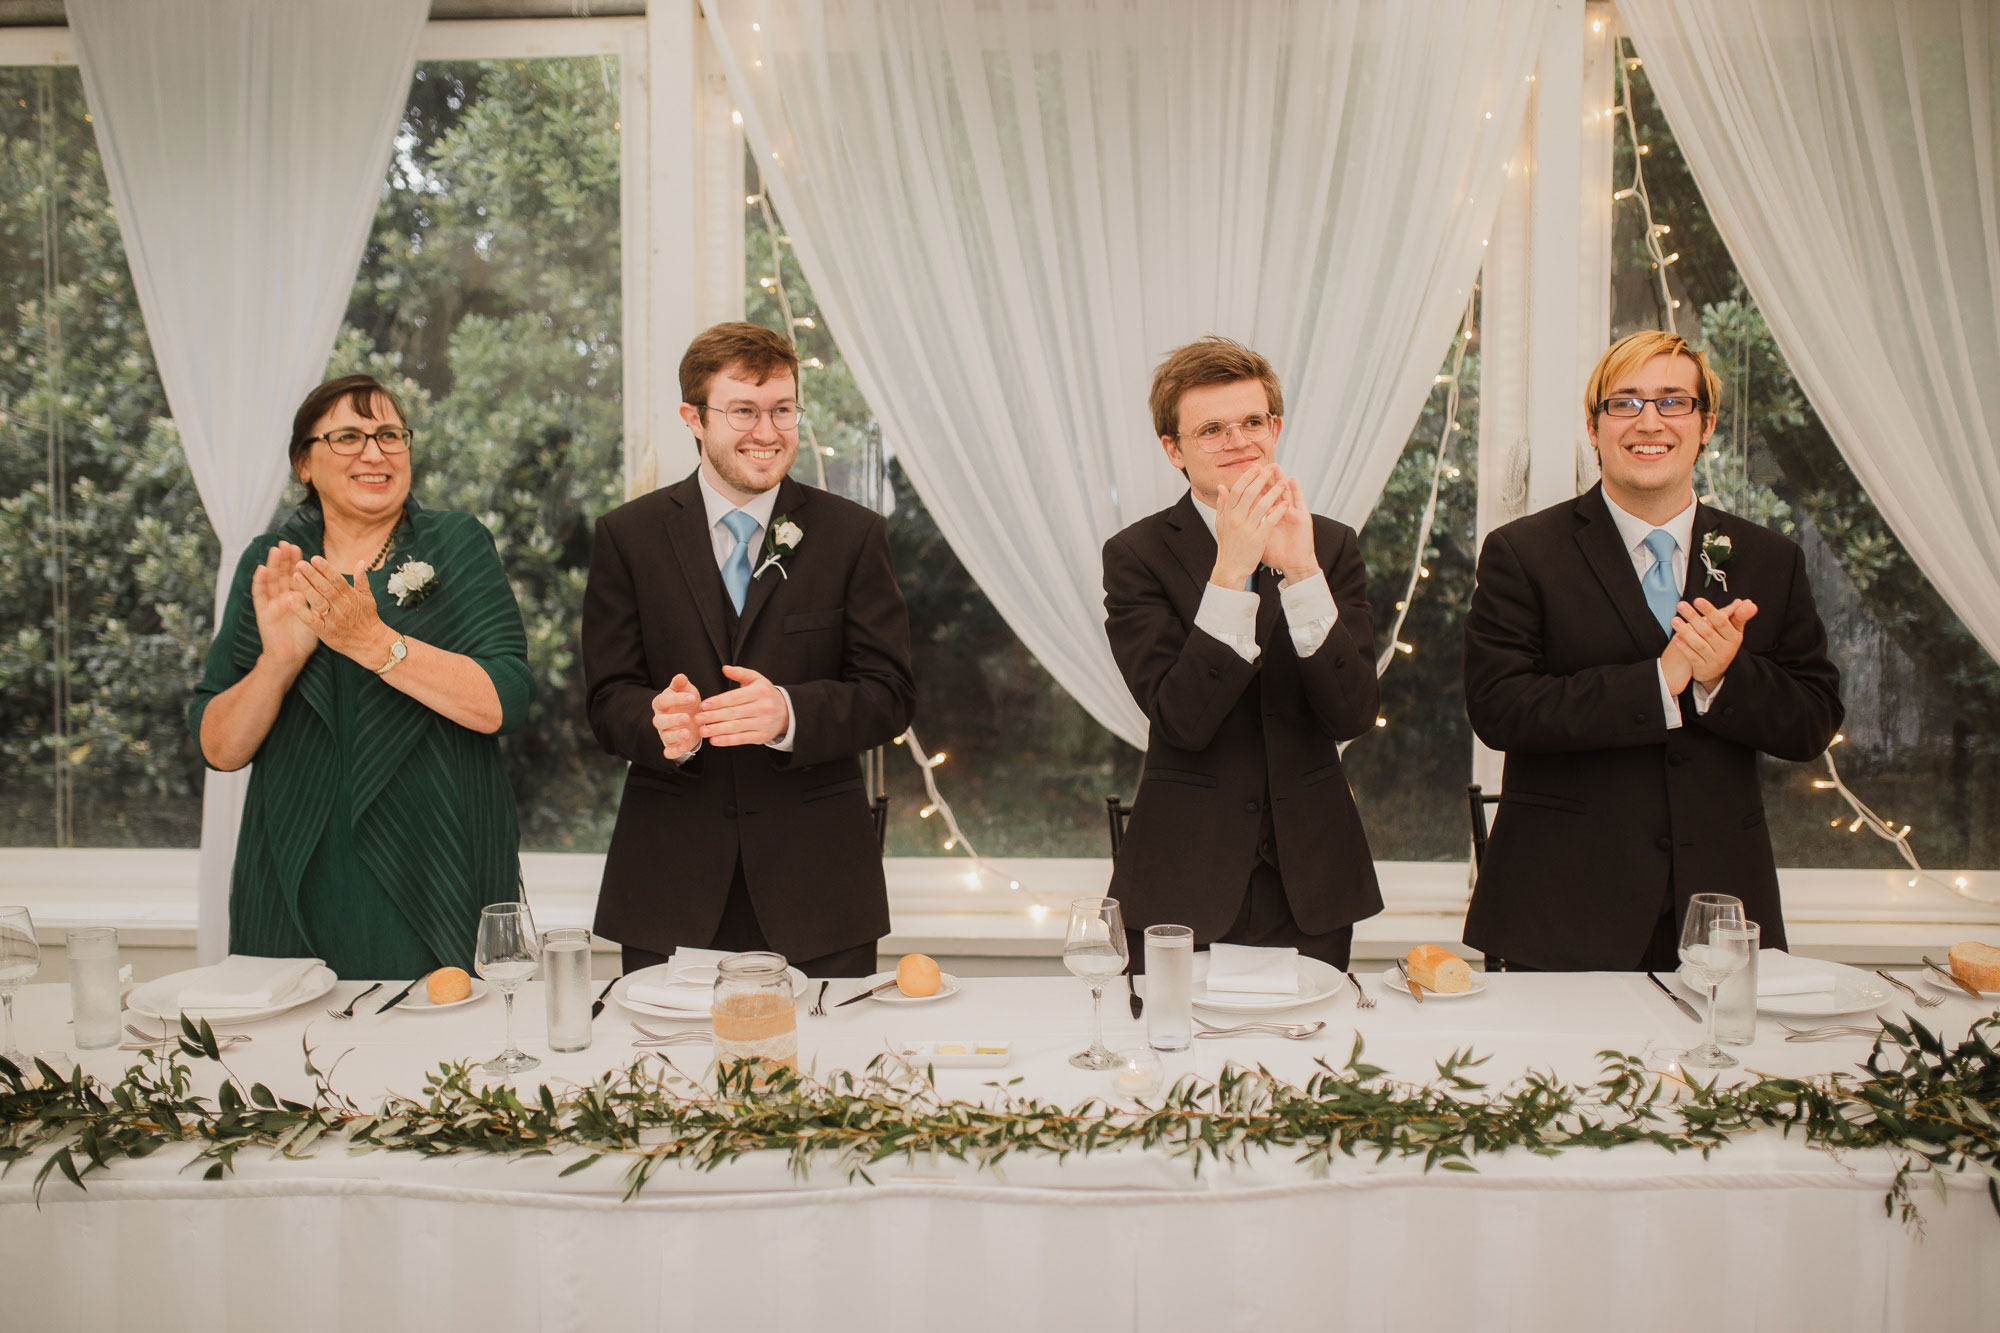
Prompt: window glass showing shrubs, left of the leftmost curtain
<box><xmin>0</xmin><ymin>66</ymin><xmax>218</xmax><ymax>847</ymax></box>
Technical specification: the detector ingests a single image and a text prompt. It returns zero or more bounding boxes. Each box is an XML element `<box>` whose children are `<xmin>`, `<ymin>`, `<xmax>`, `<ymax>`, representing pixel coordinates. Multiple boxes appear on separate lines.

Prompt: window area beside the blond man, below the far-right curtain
<box><xmin>1612</xmin><ymin>46</ymin><xmax>2000</xmax><ymax>869</ymax></box>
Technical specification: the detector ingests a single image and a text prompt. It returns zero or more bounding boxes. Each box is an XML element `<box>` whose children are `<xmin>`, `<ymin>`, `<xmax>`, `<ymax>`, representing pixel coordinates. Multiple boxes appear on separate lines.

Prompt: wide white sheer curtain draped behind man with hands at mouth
<box><xmin>710</xmin><ymin>0</ymin><xmax>1550</xmax><ymax>745</ymax></box>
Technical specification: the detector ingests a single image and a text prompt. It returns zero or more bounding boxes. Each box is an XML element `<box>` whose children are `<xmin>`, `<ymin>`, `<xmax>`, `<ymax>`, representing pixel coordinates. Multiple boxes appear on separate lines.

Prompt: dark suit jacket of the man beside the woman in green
<box><xmin>582</xmin><ymin>474</ymin><xmax>916</xmax><ymax>959</ymax></box>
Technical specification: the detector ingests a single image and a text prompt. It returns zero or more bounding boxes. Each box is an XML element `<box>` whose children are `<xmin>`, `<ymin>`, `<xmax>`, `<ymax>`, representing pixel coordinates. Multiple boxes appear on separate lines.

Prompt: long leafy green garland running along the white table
<box><xmin>0</xmin><ymin>1017</ymin><xmax>2000</xmax><ymax>1225</ymax></box>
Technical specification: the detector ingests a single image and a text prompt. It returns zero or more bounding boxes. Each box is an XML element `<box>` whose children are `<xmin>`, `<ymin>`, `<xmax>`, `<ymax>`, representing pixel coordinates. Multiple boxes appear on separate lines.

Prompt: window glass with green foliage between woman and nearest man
<box><xmin>328</xmin><ymin>56</ymin><xmax>624</xmax><ymax>851</ymax></box>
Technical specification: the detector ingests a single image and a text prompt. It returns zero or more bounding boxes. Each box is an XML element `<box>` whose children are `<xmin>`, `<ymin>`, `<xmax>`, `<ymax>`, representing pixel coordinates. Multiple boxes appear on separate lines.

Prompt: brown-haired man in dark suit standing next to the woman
<box><xmin>582</xmin><ymin>324</ymin><xmax>916</xmax><ymax>977</ymax></box>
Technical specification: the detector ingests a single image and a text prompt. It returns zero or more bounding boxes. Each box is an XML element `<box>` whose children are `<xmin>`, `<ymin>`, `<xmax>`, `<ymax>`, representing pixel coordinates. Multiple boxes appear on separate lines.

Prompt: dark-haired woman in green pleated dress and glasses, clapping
<box><xmin>188</xmin><ymin>374</ymin><xmax>534</xmax><ymax>979</ymax></box>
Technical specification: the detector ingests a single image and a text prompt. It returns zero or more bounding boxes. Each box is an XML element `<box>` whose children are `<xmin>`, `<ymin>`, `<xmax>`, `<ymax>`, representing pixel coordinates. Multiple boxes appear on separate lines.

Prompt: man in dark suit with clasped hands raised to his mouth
<box><xmin>1104</xmin><ymin>338</ymin><xmax>1382</xmax><ymax>971</ymax></box>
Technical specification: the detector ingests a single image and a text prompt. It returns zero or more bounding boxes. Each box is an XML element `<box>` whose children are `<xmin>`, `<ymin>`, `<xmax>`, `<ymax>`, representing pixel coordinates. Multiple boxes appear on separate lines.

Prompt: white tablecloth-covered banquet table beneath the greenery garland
<box><xmin>0</xmin><ymin>973</ymin><xmax>2000</xmax><ymax>1333</ymax></box>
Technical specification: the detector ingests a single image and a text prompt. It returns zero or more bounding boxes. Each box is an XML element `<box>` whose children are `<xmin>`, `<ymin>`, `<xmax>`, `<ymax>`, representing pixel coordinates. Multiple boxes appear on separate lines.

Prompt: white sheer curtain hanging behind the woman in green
<box><xmin>68</xmin><ymin>0</ymin><xmax>430</xmax><ymax>963</ymax></box>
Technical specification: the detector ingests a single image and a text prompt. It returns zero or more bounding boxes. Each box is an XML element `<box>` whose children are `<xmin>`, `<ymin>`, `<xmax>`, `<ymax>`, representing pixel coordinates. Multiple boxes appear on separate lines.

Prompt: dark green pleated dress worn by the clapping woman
<box><xmin>188</xmin><ymin>500</ymin><xmax>534</xmax><ymax>979</ymax></box>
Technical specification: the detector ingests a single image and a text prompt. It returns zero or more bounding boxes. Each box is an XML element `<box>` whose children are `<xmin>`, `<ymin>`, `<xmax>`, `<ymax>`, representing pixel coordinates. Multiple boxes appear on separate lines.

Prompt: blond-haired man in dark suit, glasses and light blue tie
<box><xmin>1466</xmin><ymin>332</ymin><xmax>1842</xmax><ymax>971</ymax></box>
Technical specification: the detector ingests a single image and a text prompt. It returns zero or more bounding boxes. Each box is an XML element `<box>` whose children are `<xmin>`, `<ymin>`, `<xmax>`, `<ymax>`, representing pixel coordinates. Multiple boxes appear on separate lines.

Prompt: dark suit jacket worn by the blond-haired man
<box><xmin>1466</xmin><ymin>486</ymin><xmax>1844</xmax><ymax>971</ymax></box>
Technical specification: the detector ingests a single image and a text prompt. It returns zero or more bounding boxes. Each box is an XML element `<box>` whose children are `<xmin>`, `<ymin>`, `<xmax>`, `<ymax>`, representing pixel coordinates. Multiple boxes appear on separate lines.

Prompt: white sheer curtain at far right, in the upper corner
<box><xmin>1618</xmin><ymin>0</ymin><xmax>2000</xmax><ymax>656</ymax></box>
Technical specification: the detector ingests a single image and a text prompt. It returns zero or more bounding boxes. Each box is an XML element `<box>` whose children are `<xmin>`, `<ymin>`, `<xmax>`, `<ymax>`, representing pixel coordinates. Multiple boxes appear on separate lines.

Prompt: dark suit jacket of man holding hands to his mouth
<box><xmin>1104</xmin><ymin>494</ymin><xmax>1382</xmax><ymax>945</ymax></box>
